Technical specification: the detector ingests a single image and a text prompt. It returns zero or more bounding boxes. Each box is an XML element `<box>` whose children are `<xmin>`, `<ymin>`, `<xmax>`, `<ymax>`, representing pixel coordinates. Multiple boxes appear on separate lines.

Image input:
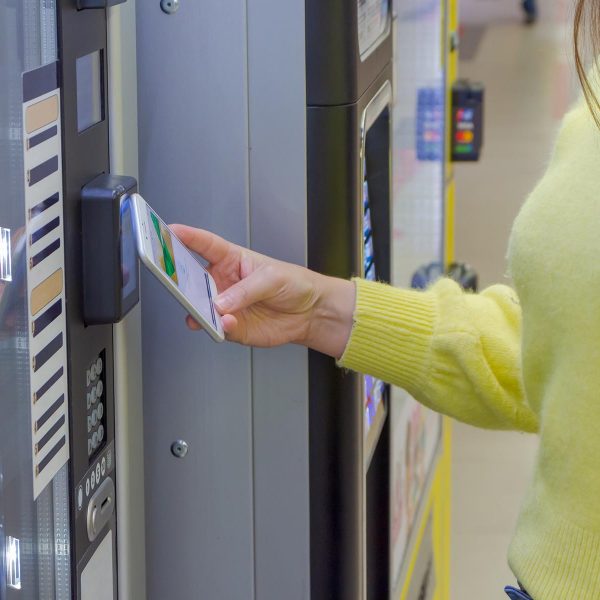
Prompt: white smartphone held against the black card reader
<box><xmin>129</xmin><ymin>194</ymin><xmax>225</xmax><ymax>342</ymax></box>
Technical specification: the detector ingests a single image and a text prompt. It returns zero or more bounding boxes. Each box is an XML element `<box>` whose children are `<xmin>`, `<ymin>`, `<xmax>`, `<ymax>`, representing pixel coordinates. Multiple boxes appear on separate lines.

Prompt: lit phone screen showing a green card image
<box><xmin>146</xmin><ymin>207</ymin><xmax>219</xmax><ymax>329</ymax></box>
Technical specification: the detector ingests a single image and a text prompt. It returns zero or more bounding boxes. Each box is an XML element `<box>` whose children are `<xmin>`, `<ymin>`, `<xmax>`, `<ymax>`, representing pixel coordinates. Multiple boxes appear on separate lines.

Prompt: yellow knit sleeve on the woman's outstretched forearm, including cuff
<box><xmin>339</xmin><ymin>279</ymin><xmax>538</xmax><ymax>432</ymax></box>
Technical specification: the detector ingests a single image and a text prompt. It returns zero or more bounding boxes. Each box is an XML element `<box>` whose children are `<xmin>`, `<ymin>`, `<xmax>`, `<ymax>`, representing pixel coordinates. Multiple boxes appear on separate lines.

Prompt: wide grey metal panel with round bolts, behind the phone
<box><xmin>137</xmin><ymin>0</ymin><xmax>254</xmax><ymax>600</ymax></box>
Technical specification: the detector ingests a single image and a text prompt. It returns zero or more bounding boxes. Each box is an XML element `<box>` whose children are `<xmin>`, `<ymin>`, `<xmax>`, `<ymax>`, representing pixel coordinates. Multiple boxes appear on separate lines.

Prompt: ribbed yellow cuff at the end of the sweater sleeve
<box><xmin>338</xmin><ymin>279</ymin><xmax>436</xmax><ymax>392</ymax></box>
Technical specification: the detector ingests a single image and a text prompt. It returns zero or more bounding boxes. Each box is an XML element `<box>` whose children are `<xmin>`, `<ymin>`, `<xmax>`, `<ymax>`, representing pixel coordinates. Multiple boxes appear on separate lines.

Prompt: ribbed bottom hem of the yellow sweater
<box><xmin>509</xmin><ymin>493</ymin><xmax>600</xmax><ymax>600</ymax></box>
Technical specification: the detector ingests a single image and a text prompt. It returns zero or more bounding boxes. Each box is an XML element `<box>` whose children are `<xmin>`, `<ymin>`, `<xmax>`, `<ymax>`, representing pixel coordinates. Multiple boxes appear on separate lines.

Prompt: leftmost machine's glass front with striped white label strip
<box><xmin>0</xmin><ymin>0</ymin><xmax>72</xmax><ymax>600</ymax></box>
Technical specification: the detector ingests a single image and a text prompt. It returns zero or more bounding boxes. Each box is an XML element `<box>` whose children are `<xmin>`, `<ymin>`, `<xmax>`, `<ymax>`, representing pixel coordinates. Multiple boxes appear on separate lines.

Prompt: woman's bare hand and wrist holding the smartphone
<box><xmin>171</xmin><ymin>225</ymin><xmax>355</xmax><ymax>358</ymax></box>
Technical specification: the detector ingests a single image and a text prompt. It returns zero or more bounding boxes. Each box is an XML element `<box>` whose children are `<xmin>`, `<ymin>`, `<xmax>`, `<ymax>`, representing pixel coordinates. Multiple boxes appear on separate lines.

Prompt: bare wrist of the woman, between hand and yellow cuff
<box><xmin>303</xmin><ymin>273</ymin><xmax>356</xmax><ymax>359</ymax></box>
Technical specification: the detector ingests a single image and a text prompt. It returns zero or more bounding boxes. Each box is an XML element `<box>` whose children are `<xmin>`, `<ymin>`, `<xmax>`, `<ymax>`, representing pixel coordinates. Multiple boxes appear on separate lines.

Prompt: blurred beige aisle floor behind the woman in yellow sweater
<box><xmin>451</xmin><ymin>0</ymin><xmax>576</xmax><ymax>600</ymax></box>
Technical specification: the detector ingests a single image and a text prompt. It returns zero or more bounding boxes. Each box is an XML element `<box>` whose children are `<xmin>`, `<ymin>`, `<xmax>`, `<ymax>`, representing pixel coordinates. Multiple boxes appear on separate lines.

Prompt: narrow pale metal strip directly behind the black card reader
<box><xmin>107</xmin><ymin>0</ymin><xmax>146</xmax><ymax>600</ymax></box>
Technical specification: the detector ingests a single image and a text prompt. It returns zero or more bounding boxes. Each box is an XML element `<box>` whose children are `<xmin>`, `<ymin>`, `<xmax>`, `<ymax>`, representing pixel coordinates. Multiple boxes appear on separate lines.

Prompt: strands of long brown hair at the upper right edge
<box><xmin>573</xmin><ymin>0</ymin><xmax>600</xmax><ymax>128</ymax></box>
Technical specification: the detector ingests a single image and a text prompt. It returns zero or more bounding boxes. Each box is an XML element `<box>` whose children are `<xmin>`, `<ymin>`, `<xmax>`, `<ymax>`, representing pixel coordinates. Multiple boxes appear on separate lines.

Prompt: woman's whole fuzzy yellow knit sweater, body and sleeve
<box><xmin>340</xmin><ymin>96</ymin><xmax>600</xmax><ymax>600</ymax></box>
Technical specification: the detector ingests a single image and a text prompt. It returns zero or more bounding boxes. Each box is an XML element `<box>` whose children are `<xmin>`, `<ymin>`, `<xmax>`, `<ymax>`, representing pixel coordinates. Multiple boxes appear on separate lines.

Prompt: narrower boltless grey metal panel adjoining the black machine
<box><xmin>248</xmin><ymin>0</ymin><xmax>310</xmax><ymax>600</ymax></box>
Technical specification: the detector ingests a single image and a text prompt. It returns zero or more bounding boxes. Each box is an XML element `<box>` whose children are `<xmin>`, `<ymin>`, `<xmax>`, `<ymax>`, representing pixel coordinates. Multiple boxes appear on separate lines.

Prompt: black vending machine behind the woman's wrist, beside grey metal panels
<box><xmin>306</xmin><ymin>0</ymin><xmax>393</xmax><ymax>599</ymax></box>
